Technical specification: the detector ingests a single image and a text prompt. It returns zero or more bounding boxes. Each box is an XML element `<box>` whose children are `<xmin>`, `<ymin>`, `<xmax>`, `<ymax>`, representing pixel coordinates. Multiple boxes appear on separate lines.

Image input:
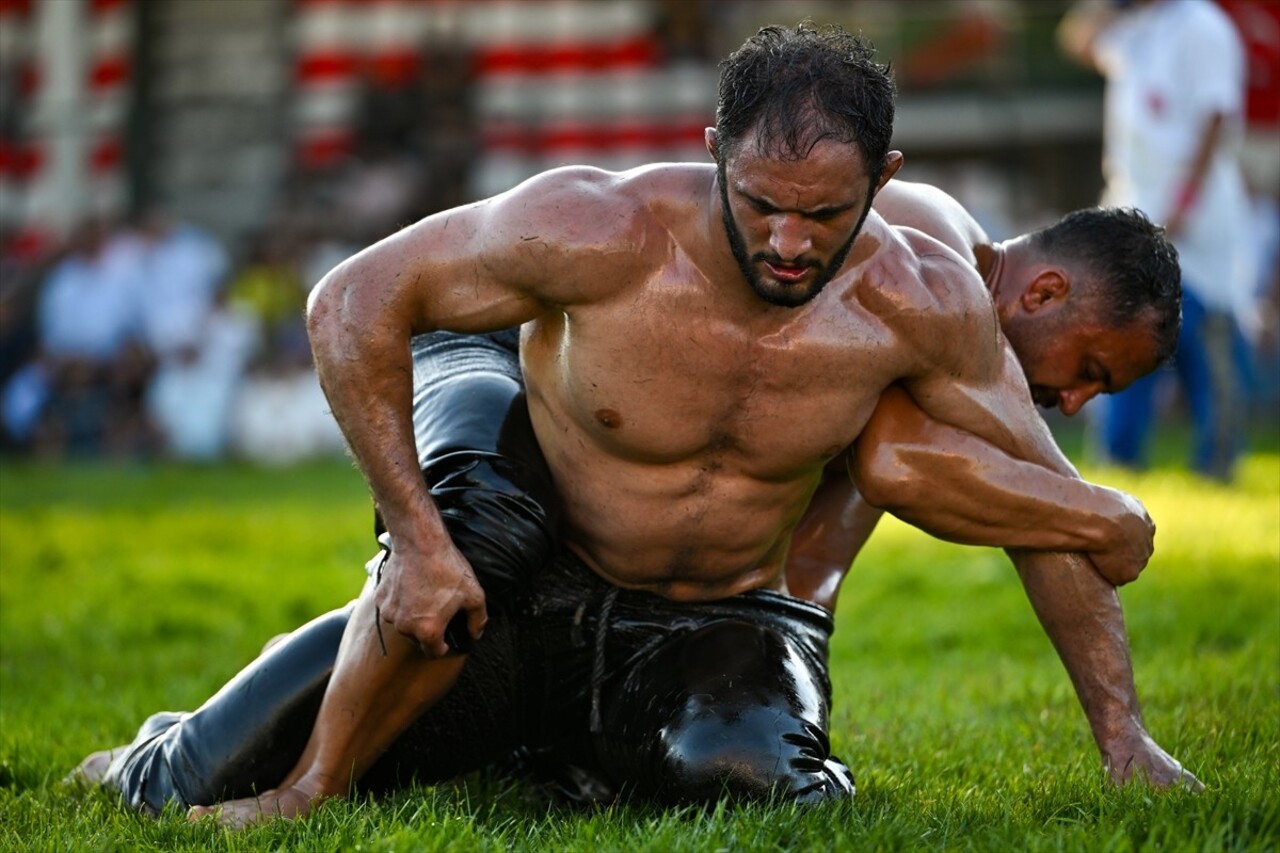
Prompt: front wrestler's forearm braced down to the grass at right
<box><xmin>1009</xmin><ymin>551</ymin><xmax>1146</xmax><ymax>757</ymax></box>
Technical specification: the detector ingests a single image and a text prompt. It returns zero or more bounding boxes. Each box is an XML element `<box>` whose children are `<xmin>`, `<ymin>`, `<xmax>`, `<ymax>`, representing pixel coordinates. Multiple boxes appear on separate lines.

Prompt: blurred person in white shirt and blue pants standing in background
<box><xmin>1059</xmin><ymin>0</ymin><xmax>1256</xmax><ymax>480</ymax></box>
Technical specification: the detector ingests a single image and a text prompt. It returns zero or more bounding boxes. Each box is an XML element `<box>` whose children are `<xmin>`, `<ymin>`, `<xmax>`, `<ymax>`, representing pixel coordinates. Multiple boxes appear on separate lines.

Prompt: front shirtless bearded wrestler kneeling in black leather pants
<box><xmin>82</xmin><ymin>27</ymin><xmax>1198</xmax><ymax>824</ymax></box>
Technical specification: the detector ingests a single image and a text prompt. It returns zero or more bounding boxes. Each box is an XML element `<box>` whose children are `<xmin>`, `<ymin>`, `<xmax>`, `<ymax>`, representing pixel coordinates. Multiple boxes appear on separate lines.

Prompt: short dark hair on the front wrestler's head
<box><xmin>716</xmin><ymin>20</ymin><xmax>895</xmax><ymax>179</ymax></box>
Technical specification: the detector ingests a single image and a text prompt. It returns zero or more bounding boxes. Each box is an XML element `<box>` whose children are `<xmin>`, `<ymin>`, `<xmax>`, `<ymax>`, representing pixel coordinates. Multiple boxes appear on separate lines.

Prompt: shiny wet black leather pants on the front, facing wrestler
<box><xmin>514</xmin><ymin>553</ymin><xmax>854</xmax><ymax>803</ymax></box>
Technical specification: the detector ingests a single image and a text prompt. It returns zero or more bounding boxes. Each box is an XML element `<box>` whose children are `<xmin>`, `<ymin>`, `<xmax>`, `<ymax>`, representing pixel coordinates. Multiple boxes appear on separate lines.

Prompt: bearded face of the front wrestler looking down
<box><xmin>718</xmin><ymin>134</ymin><xmax>872</xmax><ymax>307</ymax></box>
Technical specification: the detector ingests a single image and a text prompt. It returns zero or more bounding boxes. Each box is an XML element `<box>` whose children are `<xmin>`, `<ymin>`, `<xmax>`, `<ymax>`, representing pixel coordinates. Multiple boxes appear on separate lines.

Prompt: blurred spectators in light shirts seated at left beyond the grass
<box><xmin>0</xmin><ymin>204</ymin><xmax>340</xmax><ymax>461</ymax></box>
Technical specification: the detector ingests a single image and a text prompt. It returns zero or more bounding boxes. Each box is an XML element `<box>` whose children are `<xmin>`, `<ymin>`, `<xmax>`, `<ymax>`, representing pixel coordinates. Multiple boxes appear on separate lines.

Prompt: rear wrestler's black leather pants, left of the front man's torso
<box><xmin>104</xmin><ymin>326</ymin><xmax>554</xmax><ymax>813</ymax></box>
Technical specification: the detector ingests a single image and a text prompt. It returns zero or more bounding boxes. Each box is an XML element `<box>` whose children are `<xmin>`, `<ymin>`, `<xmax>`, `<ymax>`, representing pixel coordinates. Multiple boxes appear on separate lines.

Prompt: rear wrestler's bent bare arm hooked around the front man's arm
<box><xmin>787</xmin><ymin>386</ymin><xmax>1153</xmax><ymax>611</ymax></box>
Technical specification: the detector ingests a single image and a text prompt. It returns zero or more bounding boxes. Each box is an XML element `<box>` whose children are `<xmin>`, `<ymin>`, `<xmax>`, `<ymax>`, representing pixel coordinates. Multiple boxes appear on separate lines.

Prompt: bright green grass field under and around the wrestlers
<box><xmin>0</xmin><ymin>428</ymin><xmax>1280</xmax><ymax>850</ymax></box>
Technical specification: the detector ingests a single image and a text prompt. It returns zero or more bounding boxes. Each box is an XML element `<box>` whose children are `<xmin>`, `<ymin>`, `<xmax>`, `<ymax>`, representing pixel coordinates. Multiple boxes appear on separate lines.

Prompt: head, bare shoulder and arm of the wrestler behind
<box><xmin>787</xmin><ymin>181</ymin><xmax>1180</xmax><ymax>611</ymax></box>
